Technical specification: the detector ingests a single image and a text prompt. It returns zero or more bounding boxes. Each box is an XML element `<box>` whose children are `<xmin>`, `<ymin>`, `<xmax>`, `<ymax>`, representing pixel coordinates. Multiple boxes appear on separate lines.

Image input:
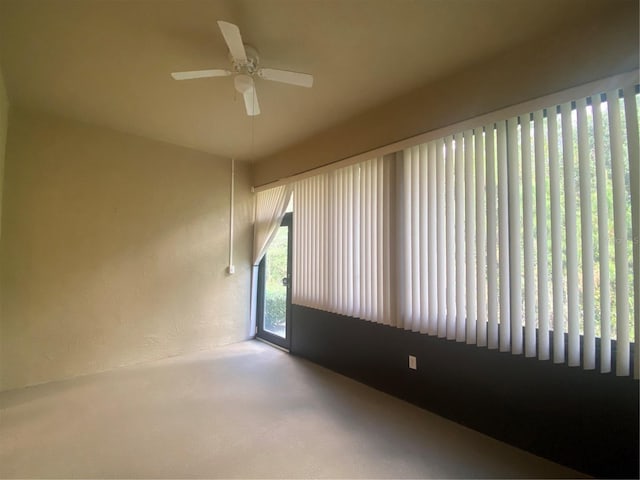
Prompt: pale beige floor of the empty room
<box><xmin>0</xmin><ymin>341</ymin><xmax>580</xmax><ymax>478</ymax></box>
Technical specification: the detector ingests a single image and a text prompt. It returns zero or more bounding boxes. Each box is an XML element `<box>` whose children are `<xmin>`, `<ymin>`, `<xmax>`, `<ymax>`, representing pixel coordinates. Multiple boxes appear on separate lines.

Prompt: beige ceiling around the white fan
<box><xmin>0</xmin><ymin>0</ymin><xmax>615</xmax><ymax>160</ymax></box>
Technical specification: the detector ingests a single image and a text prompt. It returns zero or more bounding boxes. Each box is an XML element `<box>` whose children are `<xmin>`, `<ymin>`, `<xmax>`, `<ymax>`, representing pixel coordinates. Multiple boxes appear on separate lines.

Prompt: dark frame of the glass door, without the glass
<box><xmin>256</xmin><ymin>212</ymin><xmax>293</xmax><ymax>351</ymax></box>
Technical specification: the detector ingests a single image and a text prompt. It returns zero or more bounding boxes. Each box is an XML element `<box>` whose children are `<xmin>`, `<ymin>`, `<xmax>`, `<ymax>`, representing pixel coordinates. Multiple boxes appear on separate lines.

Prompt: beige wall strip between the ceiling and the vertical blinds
<box><xmin>253</xmin><ymin>0</ymin><xmax>639</xmax><ymax>186</ymax></box>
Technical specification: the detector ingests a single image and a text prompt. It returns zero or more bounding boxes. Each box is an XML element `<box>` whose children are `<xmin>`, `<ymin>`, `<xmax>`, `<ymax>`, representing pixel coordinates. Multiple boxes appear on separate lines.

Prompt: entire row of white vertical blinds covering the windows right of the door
<box><xmin>293</xmin><ymin>81</ymin><xmax>640</xmax><ymax>376</ymax></box>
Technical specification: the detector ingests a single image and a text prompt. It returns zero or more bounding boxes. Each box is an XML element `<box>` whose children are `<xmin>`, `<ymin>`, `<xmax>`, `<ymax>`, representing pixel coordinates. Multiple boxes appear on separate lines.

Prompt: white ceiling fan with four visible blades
<box><xmin>171</xmin><ymin>20</ymin><xmax>313</xmax><ymax>116</ymax></box>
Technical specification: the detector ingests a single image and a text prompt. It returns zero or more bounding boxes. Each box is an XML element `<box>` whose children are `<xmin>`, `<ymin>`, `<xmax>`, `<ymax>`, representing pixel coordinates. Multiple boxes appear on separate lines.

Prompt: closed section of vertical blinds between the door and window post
<box><xmin>293</xmin><ymin>156</ymin><xmax>392</xmax><ymax>323</ymax></box>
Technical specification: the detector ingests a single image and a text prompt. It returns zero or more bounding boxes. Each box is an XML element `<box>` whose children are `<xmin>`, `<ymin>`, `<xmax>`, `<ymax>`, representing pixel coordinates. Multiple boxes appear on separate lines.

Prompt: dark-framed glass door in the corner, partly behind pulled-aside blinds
<box><xmin>257</xmin><ymin>213</ymin><xmax>292</xmax><ymax>350</ymax></box>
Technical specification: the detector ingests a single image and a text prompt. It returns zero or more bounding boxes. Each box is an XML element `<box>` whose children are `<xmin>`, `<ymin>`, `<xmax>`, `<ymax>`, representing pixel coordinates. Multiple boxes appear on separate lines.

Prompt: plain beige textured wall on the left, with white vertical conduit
<box><xmin>0</xmin><ymin>109</ymin><xmax>253</xmax><ymax>389</ymax></box>
